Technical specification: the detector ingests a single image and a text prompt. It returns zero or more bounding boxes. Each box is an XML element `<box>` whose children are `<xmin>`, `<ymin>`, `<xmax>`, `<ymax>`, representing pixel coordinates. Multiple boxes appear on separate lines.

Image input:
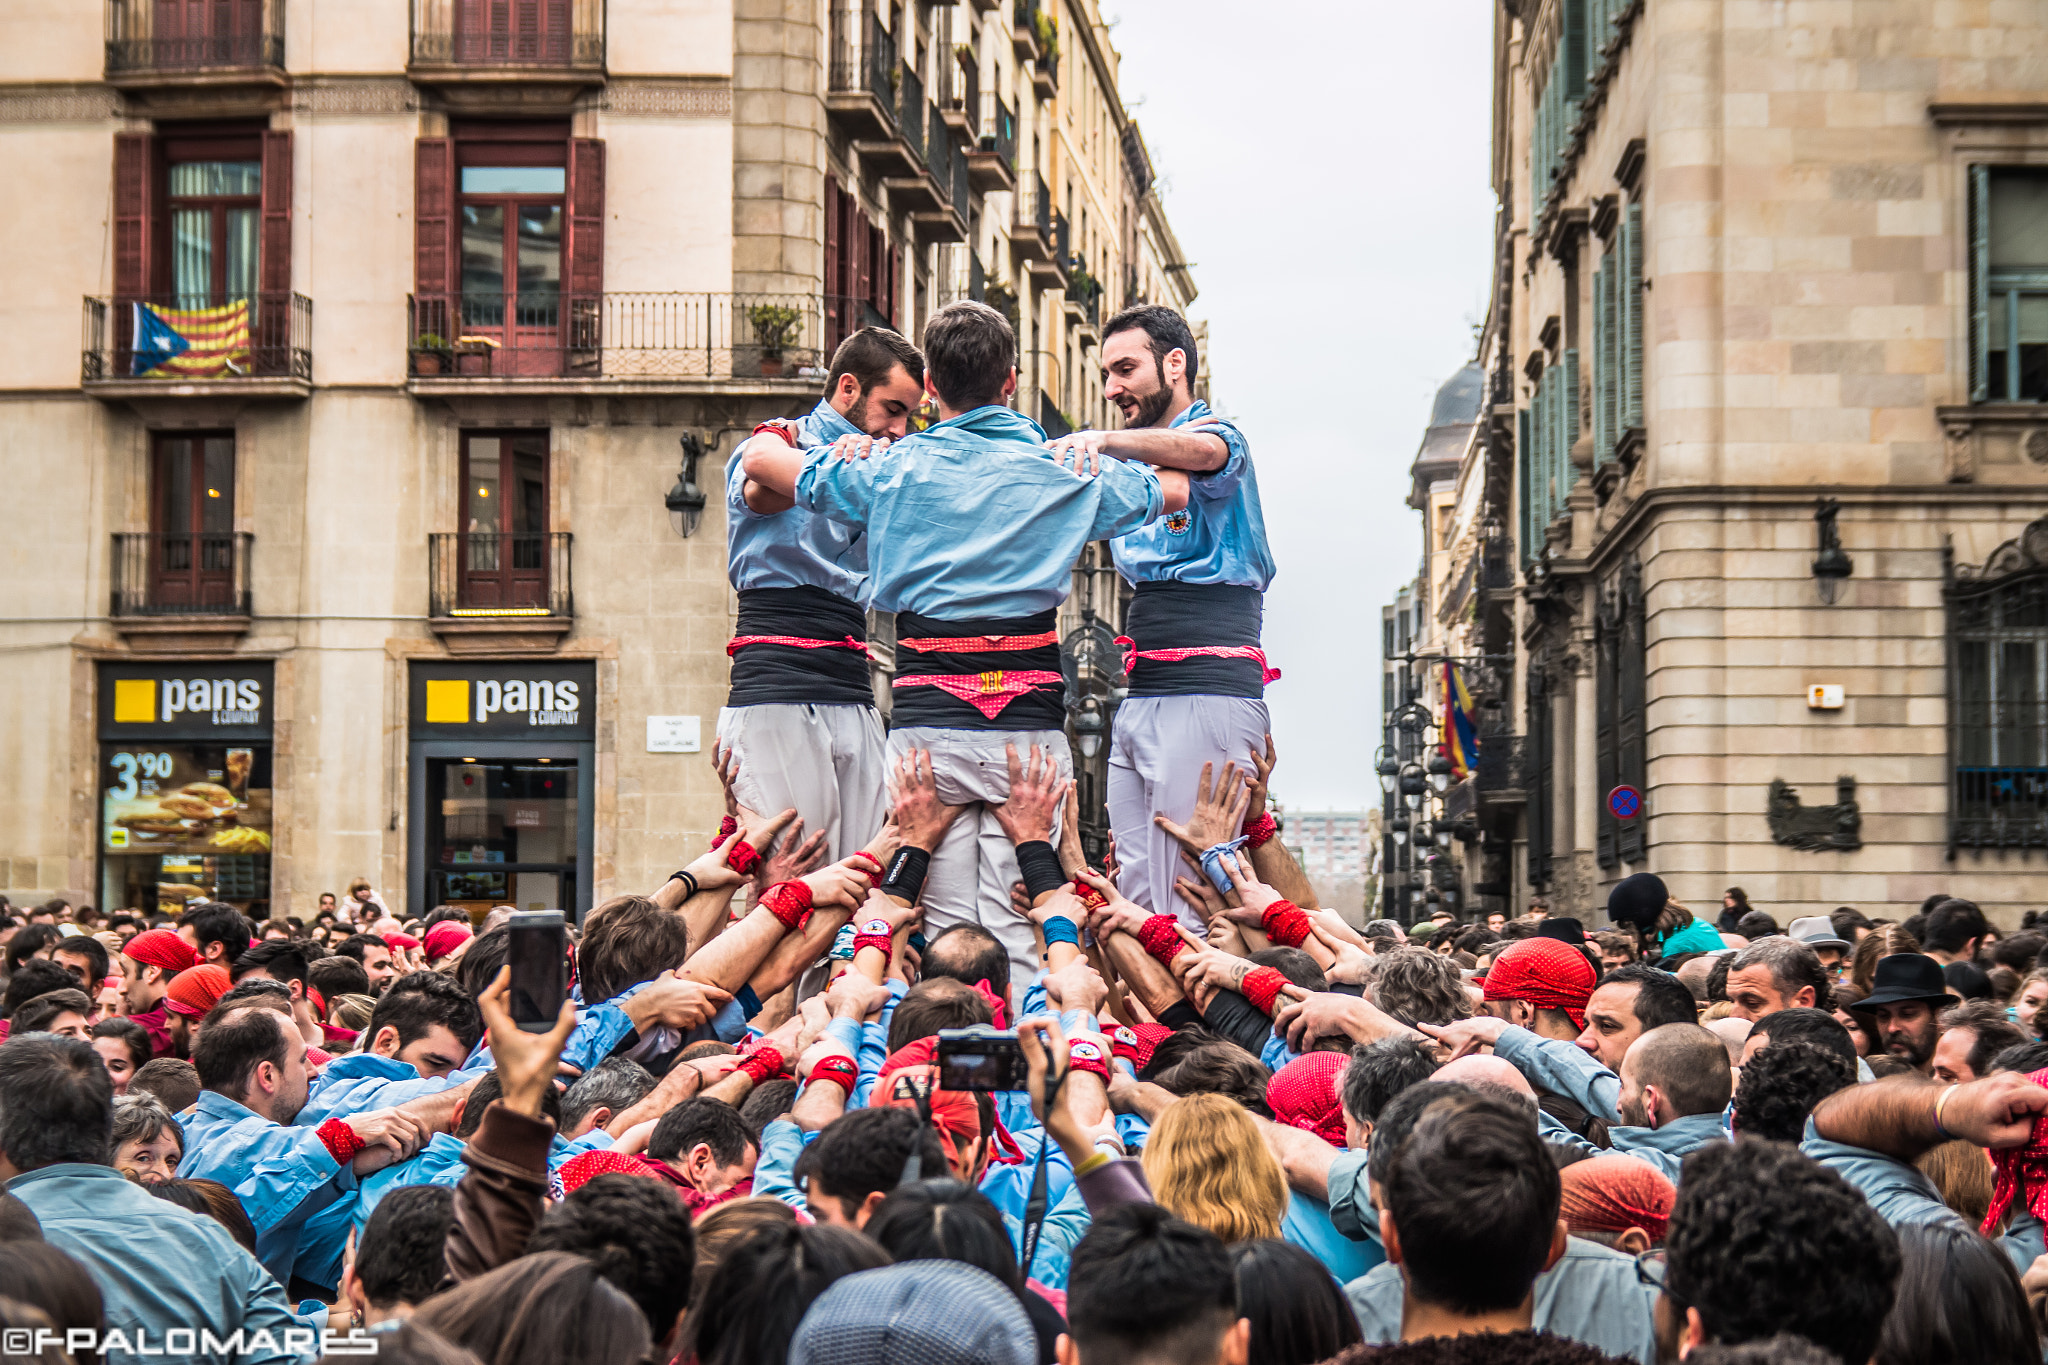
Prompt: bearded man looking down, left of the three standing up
<box><xmin>719</xmin><ymin>327</ymin><xmax>924</xmax><ymax>862</ymax></box>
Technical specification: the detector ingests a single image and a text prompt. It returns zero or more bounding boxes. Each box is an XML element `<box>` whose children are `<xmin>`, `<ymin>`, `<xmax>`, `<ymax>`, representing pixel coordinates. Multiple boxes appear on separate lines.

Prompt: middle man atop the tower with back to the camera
<box><xmin>743</xmin><ymin>303</ymin><xmax>1188</xmax><ymax>976</ymax></box>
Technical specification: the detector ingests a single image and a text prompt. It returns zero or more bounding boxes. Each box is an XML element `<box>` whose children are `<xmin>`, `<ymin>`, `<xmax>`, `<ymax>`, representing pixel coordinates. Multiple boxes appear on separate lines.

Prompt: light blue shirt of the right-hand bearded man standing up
<box><xmin>1110</xmin><ymin>399</ymin><xmax>1276</xmax><ymax>591</ymax></box>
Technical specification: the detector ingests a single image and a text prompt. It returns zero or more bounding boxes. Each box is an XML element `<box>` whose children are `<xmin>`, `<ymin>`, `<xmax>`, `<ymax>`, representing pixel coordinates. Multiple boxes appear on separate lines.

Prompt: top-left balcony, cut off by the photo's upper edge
<box><xmin>106</xmin><ymin>0</ymin><xmax>285</xmax><ymax>90</ymax></box>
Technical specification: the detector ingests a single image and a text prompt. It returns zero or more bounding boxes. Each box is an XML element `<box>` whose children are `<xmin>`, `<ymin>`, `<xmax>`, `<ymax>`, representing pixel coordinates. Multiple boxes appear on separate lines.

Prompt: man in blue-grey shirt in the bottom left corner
<box><xmin>0</xmin><ymin>1036</ymin><xmax>317</xmax><ymax>1365</ymax></box>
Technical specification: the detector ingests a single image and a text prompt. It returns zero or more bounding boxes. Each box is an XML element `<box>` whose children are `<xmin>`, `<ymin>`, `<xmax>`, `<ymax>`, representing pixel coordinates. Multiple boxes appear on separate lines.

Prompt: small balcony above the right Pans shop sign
<box><xmin>426</xmin><ymin>530</ymin><xmax>575</xmax><ymax>655</ymax></box>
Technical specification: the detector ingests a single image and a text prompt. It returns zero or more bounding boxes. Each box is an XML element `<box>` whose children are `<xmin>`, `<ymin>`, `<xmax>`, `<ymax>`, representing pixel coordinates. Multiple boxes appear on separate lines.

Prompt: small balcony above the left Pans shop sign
<box><xmin>109</xmin><ymin>532</ymin><xmax>254</xmax><ymax>651</ymax></box>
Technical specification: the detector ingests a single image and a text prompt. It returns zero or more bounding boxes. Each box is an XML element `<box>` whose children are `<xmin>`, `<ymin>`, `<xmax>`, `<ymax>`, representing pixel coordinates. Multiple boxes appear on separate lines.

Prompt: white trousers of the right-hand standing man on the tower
<box><xmin>1110</xmin><ymin>696</ymin><xmax>1272</xmax><ymax>933</ymax></box>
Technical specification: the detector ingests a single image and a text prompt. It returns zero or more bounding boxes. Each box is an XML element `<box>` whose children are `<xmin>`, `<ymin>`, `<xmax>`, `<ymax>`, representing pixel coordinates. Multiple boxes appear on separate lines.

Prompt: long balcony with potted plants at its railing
<box><xmin>408</xmin><ymin>293</ymin><xmax>827</xmax><ymax>395</ymax></box>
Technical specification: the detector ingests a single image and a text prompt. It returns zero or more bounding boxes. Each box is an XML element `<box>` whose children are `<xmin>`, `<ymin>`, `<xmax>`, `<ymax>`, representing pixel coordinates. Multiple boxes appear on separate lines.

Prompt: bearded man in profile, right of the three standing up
<box><xmin>1053</xmin><ymin>303</ymin><xmax>1280</xmax><ymax>929</ymax></box>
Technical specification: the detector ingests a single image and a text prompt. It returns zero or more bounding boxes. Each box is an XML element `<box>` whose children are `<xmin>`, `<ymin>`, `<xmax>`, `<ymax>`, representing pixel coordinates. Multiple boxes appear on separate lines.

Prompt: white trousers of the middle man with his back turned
<box><xmin>889</xmin><ymin>724</ymin><xmax>1073</xmax><ymax>986</ymax></box>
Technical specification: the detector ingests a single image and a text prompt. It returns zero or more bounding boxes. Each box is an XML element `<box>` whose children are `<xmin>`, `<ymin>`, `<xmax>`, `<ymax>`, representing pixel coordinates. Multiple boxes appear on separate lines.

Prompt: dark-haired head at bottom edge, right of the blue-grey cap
<box><xmin>1067</xmin><ymin>1203</ymin><xmax>1237</xmax><ymax>1361</ymax></box>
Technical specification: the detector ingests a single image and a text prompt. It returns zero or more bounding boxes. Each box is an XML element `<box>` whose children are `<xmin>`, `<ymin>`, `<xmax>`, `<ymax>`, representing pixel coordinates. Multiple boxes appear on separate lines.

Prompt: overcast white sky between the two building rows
<box><xmin>1102</xmin><ymin>0</ymin><xmax>1493</xmax><ymax>810</ymax></box>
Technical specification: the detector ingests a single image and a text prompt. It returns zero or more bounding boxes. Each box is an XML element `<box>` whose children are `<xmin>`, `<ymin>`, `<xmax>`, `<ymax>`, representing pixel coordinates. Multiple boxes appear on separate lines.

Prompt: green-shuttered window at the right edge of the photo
<box><xmin>1970</xmin><ymin>166</ymin><xmax>2048</xmax><ymax>403</ymax></box>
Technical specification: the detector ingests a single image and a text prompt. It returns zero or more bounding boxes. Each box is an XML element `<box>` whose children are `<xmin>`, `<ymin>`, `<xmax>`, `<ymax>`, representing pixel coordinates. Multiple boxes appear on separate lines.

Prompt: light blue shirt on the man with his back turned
<box><xmin>797</xmin><ymin>407</ymin><xmax>1165</xmax><ymax>620</ymax></box>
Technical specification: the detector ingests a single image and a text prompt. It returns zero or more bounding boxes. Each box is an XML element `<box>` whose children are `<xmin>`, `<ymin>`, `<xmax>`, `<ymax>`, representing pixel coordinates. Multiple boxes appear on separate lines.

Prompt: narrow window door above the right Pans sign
<box><xmin>457</xmin><ymin>432</ymin><xmax>551</xmax><ymax>612</ymax></box>
